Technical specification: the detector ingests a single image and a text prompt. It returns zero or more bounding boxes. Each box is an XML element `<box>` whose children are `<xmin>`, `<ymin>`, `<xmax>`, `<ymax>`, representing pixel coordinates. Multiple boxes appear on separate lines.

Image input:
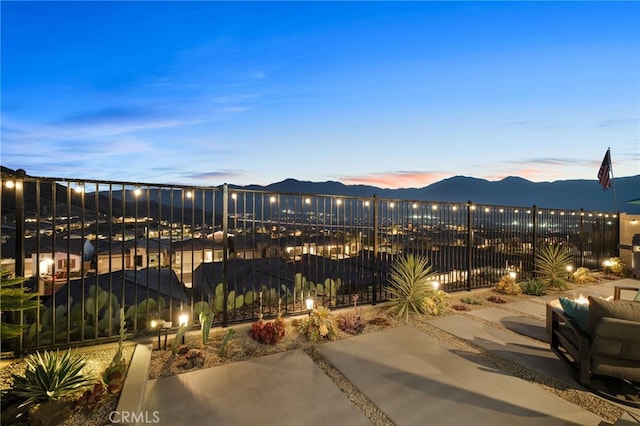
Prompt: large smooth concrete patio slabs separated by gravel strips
<box><xmin>138</xmin><ymin>280</ymin><xmax>640</xmax><ymax>426</ymax></box>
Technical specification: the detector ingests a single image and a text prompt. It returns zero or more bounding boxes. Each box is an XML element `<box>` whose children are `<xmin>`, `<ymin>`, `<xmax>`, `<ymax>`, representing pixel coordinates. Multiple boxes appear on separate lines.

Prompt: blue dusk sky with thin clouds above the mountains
<box><xmin>0</xmin><ymin>1</ymin><xmax>640</xmax><ymax>188</ymax></box>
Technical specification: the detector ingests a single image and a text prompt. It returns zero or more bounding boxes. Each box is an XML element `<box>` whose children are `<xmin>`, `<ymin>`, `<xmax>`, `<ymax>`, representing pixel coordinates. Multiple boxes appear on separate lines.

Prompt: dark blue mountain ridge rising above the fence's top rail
<box><xmin>248</xmin><ymin>175</ymin><xmax>640</xmax><ymax>214</ymax></box>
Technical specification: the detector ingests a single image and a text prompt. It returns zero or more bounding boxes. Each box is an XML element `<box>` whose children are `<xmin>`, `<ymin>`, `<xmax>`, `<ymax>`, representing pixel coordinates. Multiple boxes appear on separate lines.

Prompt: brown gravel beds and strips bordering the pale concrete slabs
<box><xmin>0</xmin><ymin>282</ymin><xmax>623</xmax><ymax>425</ymax></box>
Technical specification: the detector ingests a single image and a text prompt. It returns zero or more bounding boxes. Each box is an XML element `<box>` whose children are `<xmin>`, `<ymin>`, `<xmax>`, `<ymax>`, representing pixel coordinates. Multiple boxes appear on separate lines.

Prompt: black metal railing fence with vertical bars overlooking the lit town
<box><xmin>1</xmin><ymin>173</ymin><xmax>619</xmax><ymax>352</ymax></box>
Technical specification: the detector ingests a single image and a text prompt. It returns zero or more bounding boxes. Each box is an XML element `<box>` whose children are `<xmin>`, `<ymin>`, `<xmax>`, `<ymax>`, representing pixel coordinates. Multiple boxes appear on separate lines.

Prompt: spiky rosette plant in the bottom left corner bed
<box><xmin>9</xmin><ymin>350</ymin><xmax>91</xmax><ymax>409</ymax></box>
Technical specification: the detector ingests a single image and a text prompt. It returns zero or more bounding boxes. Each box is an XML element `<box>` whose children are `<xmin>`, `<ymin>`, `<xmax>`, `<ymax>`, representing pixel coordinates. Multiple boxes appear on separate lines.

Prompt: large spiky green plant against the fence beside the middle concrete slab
<box><xmin>385</xmin><ymin>254</ymin><xmax>435</xmax><ymax>321</ymax></box>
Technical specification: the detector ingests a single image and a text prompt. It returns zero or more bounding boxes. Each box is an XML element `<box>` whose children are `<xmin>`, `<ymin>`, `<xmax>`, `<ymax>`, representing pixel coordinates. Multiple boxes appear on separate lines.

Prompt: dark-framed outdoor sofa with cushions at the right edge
<box><xmin>547</xmin><ymin>286</ymin><xmax>640</xmax><ymax>407</ymax></box>
